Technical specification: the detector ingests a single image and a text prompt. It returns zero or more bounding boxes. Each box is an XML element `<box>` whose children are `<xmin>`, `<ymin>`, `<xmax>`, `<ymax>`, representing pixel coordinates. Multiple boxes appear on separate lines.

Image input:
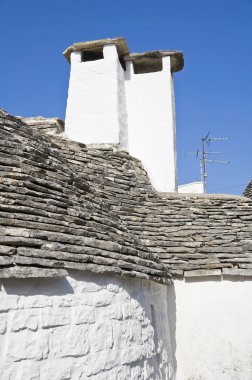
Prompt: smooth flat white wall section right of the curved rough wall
<box><xmin>174</xmin><ymin>278</ymin><xmax>252</xmax><ymax>380</ymax></box>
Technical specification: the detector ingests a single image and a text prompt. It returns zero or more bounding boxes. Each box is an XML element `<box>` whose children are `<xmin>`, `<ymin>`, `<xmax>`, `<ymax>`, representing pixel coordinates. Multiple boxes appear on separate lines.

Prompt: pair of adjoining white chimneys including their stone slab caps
<box><xmin>64</xmin><ymin>38</ymin><xmax>183</xmax><ymax>192</ymax></box>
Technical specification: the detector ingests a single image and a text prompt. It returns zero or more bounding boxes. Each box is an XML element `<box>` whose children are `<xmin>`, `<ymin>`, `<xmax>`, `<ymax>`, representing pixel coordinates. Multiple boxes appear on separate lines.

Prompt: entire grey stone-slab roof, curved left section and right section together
<box><xmin>0</xmin><ymin>108</ymin><xmax>252</xmax><ymax>281</ymax></box>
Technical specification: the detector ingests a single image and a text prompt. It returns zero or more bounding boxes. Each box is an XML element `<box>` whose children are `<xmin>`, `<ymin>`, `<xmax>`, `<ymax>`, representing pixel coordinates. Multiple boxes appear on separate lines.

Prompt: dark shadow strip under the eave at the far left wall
<box><xmin>0</xmin><ymin>278</ymin><xmax>74</xmax><ymax>297</ymax></box>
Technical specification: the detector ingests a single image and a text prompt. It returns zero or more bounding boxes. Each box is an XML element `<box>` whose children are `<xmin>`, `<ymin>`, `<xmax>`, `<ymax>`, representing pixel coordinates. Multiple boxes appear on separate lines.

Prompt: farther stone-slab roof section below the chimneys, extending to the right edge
<box><xmin>47</xmin><ymin>138</ymin><xmax>252</xmax><ymax>277</ymax></box>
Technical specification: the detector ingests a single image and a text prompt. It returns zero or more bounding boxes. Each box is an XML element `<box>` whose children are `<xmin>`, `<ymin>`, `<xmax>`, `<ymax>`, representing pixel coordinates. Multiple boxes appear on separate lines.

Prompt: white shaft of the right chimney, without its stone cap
<box><xmin>125</xmin><ymin>57</ymin><xmax>177</xmax><ymax>191</ymax></box>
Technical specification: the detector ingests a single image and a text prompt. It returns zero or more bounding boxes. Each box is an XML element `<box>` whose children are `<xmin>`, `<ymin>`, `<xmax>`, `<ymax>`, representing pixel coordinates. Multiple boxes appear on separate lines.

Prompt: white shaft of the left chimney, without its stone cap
<box><xmin>65</xmin><ymin>45</ymin><xmax>126</xmax><ymax>144</ymax></box>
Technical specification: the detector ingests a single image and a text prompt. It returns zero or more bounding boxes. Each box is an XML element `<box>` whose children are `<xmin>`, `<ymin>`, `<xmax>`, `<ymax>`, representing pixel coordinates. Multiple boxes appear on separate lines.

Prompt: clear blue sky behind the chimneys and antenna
<box><xmin>0</xmin><ymin>0</ymin><xmax>252</xmax><ymax>194</ymax></box>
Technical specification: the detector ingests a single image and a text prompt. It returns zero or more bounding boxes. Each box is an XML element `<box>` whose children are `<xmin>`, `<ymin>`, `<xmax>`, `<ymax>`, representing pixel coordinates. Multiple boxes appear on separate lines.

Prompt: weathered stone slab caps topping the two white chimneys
<box><xmin>63</xmin><ymin>37</ymin><xmax>184</xmax><ymax>72</ymax></box>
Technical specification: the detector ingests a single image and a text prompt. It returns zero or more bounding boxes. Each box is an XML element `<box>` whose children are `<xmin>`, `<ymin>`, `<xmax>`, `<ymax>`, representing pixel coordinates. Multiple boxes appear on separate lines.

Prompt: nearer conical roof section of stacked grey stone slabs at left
<box><xmin>0</xmin><ymin>108</ymin><xmax>170</xmax><ymax>282</ymax></box>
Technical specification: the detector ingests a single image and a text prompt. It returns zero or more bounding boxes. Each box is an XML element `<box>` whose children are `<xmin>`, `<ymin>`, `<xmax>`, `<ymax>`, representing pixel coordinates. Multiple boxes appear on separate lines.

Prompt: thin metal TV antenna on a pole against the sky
<box><xmin>196</xmin><ymin>132</ymin><xmax>229</xmax><ymax>193</ymax></box>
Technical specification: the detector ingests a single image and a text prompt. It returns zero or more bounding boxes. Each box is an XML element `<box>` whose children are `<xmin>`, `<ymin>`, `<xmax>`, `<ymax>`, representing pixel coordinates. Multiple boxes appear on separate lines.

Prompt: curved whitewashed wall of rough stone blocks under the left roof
<box><xmin>0</xmin><ymin>271</ymin><xmax>174</xmax><ymax>380</ymax></box>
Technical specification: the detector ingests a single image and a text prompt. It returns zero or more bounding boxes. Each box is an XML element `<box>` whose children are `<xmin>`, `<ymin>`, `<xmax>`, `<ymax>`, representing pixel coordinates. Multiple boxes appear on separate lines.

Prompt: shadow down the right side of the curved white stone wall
<box><xmin>70</xmin><ymin>271</ymin><xmax>177</xmax><ymax>379</ymax></box>
